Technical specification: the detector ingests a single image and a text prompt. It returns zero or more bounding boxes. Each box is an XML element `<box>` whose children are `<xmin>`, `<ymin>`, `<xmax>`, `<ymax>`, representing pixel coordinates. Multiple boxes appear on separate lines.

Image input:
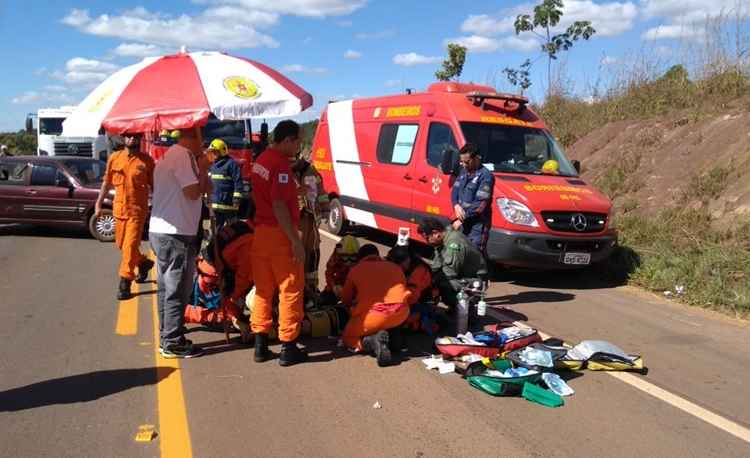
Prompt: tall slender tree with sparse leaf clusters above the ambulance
<box><xmin>503</xmin><ymin>0</ymin><xmax>596</xmax><ymax>95</ymax></box>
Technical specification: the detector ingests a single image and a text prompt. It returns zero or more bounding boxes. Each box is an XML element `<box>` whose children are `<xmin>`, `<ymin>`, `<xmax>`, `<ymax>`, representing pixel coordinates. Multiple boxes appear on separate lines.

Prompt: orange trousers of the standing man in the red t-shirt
<box><xmin>250</xmin><ymin>226</ymin><xmax>305</xmax><ymax>342</ymax></box>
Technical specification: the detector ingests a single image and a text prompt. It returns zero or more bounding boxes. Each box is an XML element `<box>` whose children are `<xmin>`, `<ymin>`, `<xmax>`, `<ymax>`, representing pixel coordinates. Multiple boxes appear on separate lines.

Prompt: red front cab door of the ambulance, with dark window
<box><xmin>412</xmin><ymin>119</ymin><xmax>458</xmax><ymax>221</ymax></box>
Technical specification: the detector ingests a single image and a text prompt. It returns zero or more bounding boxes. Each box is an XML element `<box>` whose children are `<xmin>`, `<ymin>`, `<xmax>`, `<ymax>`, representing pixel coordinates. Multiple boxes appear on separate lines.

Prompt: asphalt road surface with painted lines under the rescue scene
<box><xmin>0</xmin><ymin>226</ymin><xmax>750</xmax><ymax>457</ymax></box>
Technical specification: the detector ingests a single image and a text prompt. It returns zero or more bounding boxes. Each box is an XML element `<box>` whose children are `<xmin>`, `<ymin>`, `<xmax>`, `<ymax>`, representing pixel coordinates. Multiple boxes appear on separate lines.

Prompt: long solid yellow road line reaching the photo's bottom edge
<box><xmin>151</xmin><ymin>254</ymin><xmax>193</xmax><ymax>458</ymax></box>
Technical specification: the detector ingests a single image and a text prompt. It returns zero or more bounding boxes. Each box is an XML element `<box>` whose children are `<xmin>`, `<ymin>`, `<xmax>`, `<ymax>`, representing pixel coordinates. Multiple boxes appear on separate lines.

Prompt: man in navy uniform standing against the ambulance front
<box><xmin>451</xmin><ymin>143</ymin><xmax>495</xmax><ymax>253</ymax></box>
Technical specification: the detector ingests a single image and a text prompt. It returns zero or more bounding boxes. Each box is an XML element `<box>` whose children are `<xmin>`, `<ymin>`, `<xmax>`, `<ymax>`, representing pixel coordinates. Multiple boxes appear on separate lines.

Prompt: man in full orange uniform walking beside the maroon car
<box><xmin>94</xmin><ymin>134</ymin><xmax>154</xmax><ymax>300</ymax></box>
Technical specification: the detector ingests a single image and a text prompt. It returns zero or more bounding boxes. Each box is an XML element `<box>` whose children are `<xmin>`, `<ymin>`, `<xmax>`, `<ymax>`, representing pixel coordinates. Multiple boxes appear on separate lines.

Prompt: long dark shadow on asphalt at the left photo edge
<box><xmin>0</xmin><ymin>367</ymin><xmax>175</xmax><ymax>412</ymax></box>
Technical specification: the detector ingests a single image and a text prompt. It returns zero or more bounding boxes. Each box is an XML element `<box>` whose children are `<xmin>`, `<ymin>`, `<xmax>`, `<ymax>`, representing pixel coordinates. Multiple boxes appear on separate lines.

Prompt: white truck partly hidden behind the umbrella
<box><xmin>26</xmin><ymin>106</ymin><xmax>111</xmax><ymax>161</ymax></box>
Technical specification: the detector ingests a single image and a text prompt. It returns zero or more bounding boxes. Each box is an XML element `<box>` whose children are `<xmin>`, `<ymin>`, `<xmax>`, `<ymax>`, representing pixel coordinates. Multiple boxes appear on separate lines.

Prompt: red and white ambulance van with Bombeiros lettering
<box><xmin>312</xmin><ymin>82</ymin><xmax>617</xmax><ymax>269</ymax></box>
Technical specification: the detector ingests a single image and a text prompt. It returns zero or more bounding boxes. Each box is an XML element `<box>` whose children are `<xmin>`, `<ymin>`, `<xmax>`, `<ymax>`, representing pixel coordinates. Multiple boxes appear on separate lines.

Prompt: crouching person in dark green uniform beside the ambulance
<box><xmin>418</xmin><ymin>218</ymin><xmax>487</xmax><ymax>309</ymax></box>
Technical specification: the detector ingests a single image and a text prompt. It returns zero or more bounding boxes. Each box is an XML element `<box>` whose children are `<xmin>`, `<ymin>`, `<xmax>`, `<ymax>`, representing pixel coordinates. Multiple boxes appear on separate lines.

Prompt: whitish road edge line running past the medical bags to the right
<box><xmin>319</xmin><ymin>229</ymin><xmax>750</xmax><ymax>443</ymax></box>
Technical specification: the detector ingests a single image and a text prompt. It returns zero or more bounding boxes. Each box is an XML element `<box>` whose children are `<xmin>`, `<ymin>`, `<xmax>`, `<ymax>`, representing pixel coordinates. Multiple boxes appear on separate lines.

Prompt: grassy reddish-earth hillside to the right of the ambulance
<box><xmin>540</xmin><ymin>66</ymin><xmax>750</xmax><ymax>317</ymax></box>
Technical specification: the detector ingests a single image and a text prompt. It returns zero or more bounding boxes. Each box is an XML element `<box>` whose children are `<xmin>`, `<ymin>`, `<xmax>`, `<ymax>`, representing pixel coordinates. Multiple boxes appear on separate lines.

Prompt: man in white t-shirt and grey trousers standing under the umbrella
<box><xmin>149</xmin><ymin>129</ymin><xmax>211</xmax><ymax>358</ymax></box>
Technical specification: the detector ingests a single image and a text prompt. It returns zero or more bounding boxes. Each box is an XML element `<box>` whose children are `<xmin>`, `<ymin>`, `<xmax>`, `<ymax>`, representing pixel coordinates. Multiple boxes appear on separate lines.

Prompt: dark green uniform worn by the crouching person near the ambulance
<box><xmin>430</xmin><ymin>228</ymin><xmax>487</xmax><ymax>307</ymax></box>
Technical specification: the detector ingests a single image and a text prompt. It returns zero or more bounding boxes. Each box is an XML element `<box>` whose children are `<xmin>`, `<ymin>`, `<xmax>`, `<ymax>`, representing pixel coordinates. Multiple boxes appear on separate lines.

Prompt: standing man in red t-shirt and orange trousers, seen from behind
<box><xmin>251</xmin><ymin>120</ymin><xmax>307</xmax><ymax>366</ymax></box>
